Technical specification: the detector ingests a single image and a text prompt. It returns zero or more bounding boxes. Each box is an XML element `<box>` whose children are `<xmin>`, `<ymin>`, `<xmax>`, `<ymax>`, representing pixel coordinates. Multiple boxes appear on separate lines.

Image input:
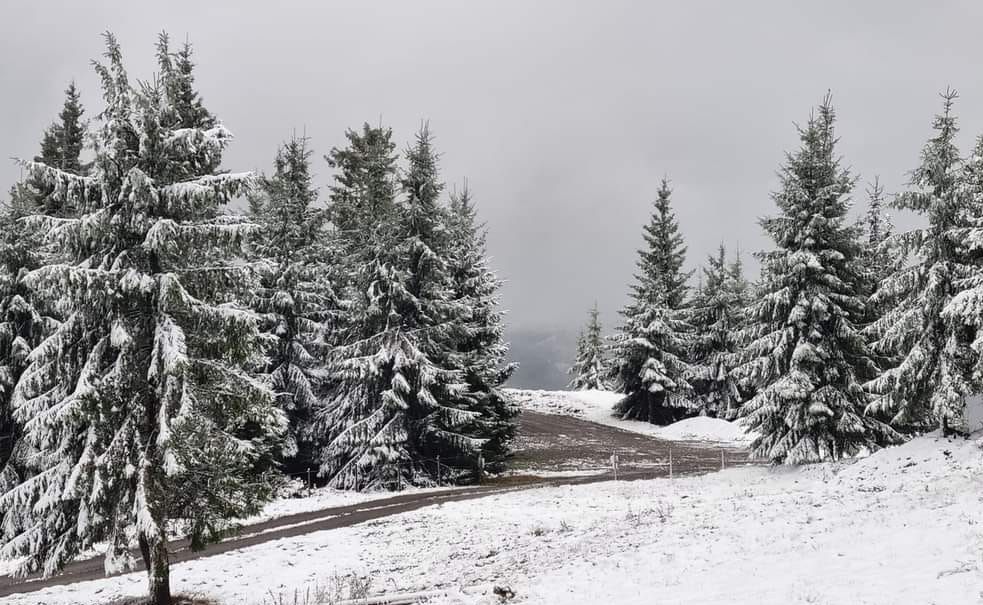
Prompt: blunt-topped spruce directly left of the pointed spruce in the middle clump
<box><xmin>316</xmin><ymin>123</ymin><xmax>402</xmax><ymax>489</ymax></box>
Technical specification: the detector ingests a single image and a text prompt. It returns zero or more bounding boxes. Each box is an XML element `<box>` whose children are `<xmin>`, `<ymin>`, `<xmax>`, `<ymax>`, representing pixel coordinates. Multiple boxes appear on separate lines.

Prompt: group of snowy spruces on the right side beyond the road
<box><xmin>571</xmin><ymin>91</ymin><xmax>983</xmax><ymax>464</ymax></box>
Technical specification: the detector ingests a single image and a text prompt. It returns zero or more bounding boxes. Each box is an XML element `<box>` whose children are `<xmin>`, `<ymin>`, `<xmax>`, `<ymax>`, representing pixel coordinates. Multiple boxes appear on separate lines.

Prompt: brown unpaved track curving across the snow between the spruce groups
<box><xmin>0</xmin><ymin>412</ymin><xmax>747</xmax><ymax>597</ymax></box>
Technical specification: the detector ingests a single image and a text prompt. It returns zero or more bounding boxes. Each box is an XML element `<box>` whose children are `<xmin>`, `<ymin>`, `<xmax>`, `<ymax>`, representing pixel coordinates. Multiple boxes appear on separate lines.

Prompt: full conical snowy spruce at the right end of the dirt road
<box><xmin>735</xmin><ymin>95</ymin><xmax>894</xmax><ymax>464</ymax></box>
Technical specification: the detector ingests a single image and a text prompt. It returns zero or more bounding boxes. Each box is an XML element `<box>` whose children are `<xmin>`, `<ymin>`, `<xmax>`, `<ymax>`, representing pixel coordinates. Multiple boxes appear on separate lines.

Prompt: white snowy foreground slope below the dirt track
<box><xmin>5</xmin><ymin>437</ymin><xmax>983</xmax><ymax>605</ymax></box>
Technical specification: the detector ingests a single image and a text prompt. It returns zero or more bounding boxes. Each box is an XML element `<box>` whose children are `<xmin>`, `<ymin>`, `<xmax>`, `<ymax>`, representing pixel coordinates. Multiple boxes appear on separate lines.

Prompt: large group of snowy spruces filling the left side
<box><xmin>0</xmin><ymin>34</ymin><xmax>517</xmax><ymax>604</ymax></box>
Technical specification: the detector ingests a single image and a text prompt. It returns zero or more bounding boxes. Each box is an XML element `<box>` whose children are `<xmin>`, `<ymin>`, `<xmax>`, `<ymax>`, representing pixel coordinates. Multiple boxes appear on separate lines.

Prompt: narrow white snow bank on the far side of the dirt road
<box><xmin>509</xmin><ymin>389</ymin><xmax>754</xmax><ymax>446</ymax></box>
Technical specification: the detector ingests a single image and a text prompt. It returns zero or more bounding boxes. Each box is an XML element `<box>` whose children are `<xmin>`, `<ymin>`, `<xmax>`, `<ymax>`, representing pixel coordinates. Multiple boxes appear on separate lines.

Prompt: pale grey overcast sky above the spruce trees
<box><xmin>0</xmin><ymin>0</ymin><xmax>983</xmax><ymax>328</ymax></box>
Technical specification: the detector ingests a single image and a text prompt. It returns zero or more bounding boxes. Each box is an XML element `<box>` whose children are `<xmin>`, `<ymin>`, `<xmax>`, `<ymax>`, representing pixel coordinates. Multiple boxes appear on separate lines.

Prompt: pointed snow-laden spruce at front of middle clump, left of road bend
<box><xmin>321</xmin><ymin>127</ymin><xmax>486</xmax><ymax>489</ymax></box>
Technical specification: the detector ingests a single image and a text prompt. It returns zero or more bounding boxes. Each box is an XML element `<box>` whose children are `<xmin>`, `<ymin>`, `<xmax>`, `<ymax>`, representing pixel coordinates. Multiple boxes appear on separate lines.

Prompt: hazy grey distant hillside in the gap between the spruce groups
<box><xmin>507</xmin><ymin>328</ymin><xmax>577</xmax><ymax>389</ymax></box>
